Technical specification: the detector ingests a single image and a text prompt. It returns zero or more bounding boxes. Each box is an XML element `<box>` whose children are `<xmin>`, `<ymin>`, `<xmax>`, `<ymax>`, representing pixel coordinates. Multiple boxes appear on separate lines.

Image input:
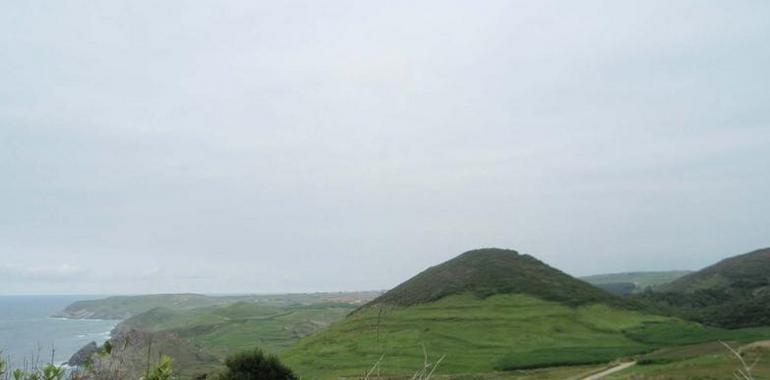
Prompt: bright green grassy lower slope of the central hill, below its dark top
<box><xmin>279</xmin><ymin>293</ymin><xmax>770</xmax><ymax>379</ymax></box>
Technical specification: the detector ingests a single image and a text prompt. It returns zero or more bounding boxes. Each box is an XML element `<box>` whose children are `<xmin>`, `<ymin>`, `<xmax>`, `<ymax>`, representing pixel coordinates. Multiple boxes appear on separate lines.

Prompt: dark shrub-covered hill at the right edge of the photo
<box><xmin>639</xmin><ymin>248</ymin><xmax>770</xmax><ymax>328</ymax></box>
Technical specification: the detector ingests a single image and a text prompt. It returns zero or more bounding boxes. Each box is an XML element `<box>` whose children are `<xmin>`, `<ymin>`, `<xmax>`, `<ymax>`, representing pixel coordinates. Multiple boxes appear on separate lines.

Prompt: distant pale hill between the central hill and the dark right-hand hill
<box><xmin>580</xmin><ymin>271</ymin><xmax>692</xmax><ymax>294</ymax></box>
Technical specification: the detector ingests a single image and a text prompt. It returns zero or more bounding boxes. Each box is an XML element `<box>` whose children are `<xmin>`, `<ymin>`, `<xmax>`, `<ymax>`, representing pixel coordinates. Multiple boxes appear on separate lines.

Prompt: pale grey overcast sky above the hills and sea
<box><xmin>0</xmin><ymin>0</ymin><xmax>770</xmax><ymax>294</ymax></box>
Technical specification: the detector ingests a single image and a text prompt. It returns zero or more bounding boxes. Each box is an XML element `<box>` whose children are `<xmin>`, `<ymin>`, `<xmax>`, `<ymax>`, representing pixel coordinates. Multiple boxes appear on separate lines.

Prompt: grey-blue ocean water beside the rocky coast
<box><xmin>0</xmin><ymin>296</ymin><xmax>118</xmax><ymax>368</ymax></box>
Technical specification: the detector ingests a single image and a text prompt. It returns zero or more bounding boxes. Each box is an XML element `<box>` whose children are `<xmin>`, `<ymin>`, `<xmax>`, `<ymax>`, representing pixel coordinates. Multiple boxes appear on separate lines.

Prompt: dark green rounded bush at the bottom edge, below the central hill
<box><xmin>219</xmin><ymin>349</ymin><xmax>298</xmax><ymax>380</ymax></box>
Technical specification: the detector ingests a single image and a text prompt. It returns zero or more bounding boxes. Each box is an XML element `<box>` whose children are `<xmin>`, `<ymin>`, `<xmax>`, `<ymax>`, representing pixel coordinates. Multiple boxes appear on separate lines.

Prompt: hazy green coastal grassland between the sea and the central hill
<box><xmin>66</xmin><ymin>292</ymin><xmax>379</xmax><ymax>378</ymax></box>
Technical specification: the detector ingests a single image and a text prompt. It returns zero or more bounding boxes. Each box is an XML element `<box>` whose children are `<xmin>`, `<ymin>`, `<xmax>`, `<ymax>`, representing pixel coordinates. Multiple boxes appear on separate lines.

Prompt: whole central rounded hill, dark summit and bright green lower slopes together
<box><xmin>279</xmin><ymin>249</ymin><xmax>770</xmax><ymax>379</ymax></box>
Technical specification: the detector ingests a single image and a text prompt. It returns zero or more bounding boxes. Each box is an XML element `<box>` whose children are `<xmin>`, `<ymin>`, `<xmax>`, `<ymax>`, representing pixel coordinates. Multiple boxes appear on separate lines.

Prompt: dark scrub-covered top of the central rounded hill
<box><xmin>369</xmin><ymin>248</ymin><xmax>619</xmax><ymax>306</ymax></box>
